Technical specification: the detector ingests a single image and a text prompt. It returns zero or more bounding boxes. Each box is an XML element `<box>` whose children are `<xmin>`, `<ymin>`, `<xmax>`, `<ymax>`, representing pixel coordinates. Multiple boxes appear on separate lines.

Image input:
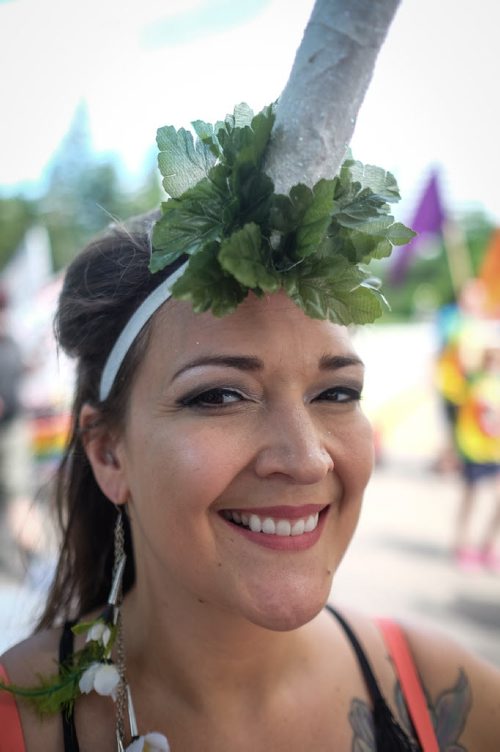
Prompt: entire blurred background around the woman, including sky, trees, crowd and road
<box><xmin>0</xmin><ymin>0</ymin><xmax>500</xmax><ymax>665</ymax></box>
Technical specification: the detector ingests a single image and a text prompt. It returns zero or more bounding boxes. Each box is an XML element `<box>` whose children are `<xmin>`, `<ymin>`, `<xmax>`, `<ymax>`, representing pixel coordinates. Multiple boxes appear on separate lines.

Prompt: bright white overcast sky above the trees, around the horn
<box><xmin>0</xmin><ymin>0</ymin><xmax>500</xmax><ymax>223</ymax></box>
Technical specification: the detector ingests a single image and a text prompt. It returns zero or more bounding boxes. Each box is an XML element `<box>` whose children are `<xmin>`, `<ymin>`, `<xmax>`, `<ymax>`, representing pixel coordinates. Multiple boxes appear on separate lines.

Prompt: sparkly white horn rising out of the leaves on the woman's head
<box><xmin>264</xmin><ymin>0</ymin><xmax>399</xmax><ymax>193</ymax></box>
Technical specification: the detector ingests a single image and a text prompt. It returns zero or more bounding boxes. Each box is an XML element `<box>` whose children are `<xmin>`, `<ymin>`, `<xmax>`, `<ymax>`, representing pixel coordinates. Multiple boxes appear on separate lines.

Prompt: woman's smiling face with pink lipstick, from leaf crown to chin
<box><xmin>118</xmin><ymin>293</ymin><xmax>372</xmax><ymax>630</ymax></box>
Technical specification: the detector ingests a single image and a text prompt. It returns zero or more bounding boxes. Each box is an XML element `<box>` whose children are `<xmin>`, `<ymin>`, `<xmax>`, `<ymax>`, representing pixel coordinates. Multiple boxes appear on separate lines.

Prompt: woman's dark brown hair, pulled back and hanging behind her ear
<box><xmin>37</xmin><ymin>213</ymin><xmax>184</xmax><ymax>630</ymax></box>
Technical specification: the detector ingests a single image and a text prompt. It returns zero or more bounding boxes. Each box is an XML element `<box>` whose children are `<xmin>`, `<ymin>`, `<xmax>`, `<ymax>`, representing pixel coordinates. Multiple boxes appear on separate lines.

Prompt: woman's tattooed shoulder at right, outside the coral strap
<box><xmin>404</xmin><ymin>625</ymin><xmax>500</xmax><ymax>752</ymax></box>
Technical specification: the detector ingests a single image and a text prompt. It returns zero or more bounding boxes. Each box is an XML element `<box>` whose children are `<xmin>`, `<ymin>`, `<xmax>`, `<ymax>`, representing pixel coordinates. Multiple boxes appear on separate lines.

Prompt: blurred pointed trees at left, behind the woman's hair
<box><xmin>0</xmin><ymin>104</ymin><xmax>161</xmax><ymax>271</ymax></box>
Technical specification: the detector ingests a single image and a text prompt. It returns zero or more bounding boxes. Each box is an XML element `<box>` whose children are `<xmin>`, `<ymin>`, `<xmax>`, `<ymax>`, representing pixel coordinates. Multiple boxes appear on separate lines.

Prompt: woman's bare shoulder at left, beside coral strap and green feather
<box><xmin>0</xmin><ymin>629</ymin><xmax>63</xmax><ymax>752</ymax></box>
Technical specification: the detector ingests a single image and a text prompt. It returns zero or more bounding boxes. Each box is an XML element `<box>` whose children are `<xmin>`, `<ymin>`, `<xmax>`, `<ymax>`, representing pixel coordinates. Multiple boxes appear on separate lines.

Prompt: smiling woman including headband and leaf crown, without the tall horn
<box><xmin>0</xmin><ymin>7</ymin><xmax>500</xmax><ymax>752</ymax></box>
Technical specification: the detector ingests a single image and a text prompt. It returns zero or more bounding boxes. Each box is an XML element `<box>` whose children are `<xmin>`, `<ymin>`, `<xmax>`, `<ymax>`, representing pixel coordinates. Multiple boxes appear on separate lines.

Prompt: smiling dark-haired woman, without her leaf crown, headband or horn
<box><xmin>0</xmin><ymin>195</ymin><xmax>500</xmax><ymax>752</ymax></box>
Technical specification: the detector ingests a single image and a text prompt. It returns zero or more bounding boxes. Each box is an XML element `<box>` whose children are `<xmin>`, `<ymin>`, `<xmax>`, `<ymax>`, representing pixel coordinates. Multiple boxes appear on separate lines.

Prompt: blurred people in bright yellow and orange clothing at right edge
<box><xmin>436</xmin><ymin>279</ymin><xmax>500</xmax><ymax>572</ymax></box>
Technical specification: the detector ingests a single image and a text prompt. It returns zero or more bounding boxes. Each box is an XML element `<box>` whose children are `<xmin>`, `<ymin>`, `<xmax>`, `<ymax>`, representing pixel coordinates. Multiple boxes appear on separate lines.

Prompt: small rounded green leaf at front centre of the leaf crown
<box><xmin>219</xmin><ymin>223</ymin><xmax>280</xmax><ymax>292</ymax></box>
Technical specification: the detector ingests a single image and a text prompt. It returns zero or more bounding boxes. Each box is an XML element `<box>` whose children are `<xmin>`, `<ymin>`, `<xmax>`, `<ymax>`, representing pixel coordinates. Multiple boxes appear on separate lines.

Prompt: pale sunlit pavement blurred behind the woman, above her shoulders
<box><xmin>0</xmin><ymin>461</ymin><xmax>500</xmax><ymax>666</ymax></box>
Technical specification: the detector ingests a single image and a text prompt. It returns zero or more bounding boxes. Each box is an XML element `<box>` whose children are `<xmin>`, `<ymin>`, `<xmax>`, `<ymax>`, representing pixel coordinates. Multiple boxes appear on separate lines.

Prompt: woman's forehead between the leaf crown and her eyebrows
<box><xmin>150</xmin><ymin>292</ymin><xmax>355</xmax><ymax>363</ymax></box>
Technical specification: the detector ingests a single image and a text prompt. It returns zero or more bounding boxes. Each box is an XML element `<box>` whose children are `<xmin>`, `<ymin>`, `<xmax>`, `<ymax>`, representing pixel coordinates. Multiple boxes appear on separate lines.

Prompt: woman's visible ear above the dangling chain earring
<box><xmin>79</xmin><ymin>403</ymin><xmax>129</xmax><ymax>504</ymax></box>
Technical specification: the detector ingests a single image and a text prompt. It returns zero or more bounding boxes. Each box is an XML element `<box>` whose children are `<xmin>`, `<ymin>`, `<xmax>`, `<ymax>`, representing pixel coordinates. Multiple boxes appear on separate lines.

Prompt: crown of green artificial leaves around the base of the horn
<box><xmin>150</xmin><ymin>104</ymin><xmax>415</xmax><ymax>324</ymax></box>
